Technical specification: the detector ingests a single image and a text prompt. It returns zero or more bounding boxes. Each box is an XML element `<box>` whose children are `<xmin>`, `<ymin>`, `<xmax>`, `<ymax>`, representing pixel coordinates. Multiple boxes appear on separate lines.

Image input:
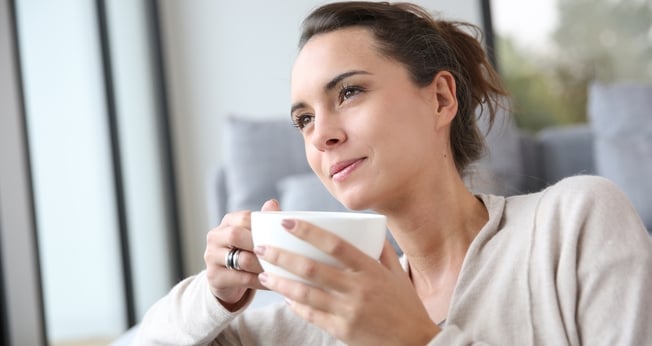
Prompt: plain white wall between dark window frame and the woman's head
<box><xmin>161</xmin><ymin>0</ymin><xmax>482</xmax><ymax>274</ymax></box>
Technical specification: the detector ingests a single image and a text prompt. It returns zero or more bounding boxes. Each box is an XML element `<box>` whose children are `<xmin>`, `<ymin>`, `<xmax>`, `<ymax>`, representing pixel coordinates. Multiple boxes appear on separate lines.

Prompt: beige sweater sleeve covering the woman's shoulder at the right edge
<box><xmin>539</xmin><ymin>177</ymin><xmax>652</xmax><ymax>345</ymax></box>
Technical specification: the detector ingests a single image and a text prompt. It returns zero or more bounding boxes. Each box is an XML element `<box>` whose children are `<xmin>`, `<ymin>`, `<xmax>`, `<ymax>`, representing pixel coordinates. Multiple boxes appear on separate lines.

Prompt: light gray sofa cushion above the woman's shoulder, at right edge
<box><xmin>588</xmin><ymin>83</ymin><xmax>652</xmax><ymax>230</ymax></box>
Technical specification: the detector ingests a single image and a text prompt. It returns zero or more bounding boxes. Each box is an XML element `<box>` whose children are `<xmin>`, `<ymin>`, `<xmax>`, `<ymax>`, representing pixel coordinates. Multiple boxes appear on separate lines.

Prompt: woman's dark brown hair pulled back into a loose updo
<box><xmin>299</xmin><ymin>1</ymin><xmax>507</xmax><ymax>174</ymax></box>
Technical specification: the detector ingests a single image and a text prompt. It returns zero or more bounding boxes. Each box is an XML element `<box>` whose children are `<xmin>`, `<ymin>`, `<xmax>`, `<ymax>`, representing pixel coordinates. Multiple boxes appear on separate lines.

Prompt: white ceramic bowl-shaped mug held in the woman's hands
<box><xmin>251</xmin><ymin>211</ymin><xmax>387</xmax><ymax>283</ymax></box>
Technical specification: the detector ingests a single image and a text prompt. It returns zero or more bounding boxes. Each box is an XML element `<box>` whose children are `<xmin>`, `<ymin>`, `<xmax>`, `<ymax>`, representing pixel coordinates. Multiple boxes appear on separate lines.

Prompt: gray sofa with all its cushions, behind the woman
<box><xmin>215</xmin><ymin>83</ymin><xmax>652</xmax><ymax>235</ymax></box>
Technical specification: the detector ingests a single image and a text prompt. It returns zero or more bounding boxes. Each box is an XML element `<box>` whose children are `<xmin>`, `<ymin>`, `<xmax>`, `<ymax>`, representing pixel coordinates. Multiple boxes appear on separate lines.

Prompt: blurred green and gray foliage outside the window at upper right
<box><xmin>496</xmin><ymin>0</ymin><xmax>652</xmax><ymax>132</ymax></box>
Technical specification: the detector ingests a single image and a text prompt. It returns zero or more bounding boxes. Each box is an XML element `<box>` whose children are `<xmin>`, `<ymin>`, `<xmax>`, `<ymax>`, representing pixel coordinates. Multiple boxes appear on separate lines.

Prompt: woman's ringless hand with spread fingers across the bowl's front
<box><xmin>255</xmin><ymin>220</ymin><xmax>440</xmax><ymax>345</ymax></box>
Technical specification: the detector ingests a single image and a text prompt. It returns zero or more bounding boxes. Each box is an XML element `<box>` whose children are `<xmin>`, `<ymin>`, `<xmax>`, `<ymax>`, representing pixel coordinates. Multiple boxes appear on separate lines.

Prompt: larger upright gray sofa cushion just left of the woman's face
<box><xmin>223</xmin><ymin>116</ymin><xmax>311</xmax><ymax>211</ymax></box>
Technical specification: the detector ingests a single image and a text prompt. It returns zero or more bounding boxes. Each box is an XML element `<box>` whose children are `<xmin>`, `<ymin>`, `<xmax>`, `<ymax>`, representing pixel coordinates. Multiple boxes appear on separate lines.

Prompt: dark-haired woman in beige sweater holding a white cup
<box><xmin>139</xmin><ymin>2</ymin><xmax>652</xmax><ymax>345</ymax></box>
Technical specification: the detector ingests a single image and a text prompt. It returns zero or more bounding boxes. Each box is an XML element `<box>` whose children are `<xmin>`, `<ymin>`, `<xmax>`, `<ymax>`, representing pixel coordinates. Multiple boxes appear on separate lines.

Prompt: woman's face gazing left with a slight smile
<box><xmin>291</xmin><ymin>28</ymin><xmax>446</xmax><ymax>210</ymax></box>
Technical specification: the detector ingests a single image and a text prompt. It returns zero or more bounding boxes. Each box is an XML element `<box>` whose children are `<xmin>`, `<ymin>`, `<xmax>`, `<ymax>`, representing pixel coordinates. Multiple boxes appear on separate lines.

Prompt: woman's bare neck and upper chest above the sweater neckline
<box><xmin>386</xmin><ymin>179</ymin><xmax>489</xmax><ymax>296</ymax></box>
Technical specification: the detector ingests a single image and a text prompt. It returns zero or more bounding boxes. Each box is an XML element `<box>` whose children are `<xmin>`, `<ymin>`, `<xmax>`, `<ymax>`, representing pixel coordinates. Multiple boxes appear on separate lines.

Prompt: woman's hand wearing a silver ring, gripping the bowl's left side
<box><xmin>204</xmin><ymin>200</ymin><xmax>279</xmax><ymax>311</ymax></box>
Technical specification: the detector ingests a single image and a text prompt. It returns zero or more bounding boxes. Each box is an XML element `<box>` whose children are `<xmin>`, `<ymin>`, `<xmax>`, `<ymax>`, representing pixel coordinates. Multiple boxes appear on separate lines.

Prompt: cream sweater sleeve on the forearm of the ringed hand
<box><xmin>136</xmin><ymin>271</ymin><xmax>254</xmax><ymax>345</ymax></box>
